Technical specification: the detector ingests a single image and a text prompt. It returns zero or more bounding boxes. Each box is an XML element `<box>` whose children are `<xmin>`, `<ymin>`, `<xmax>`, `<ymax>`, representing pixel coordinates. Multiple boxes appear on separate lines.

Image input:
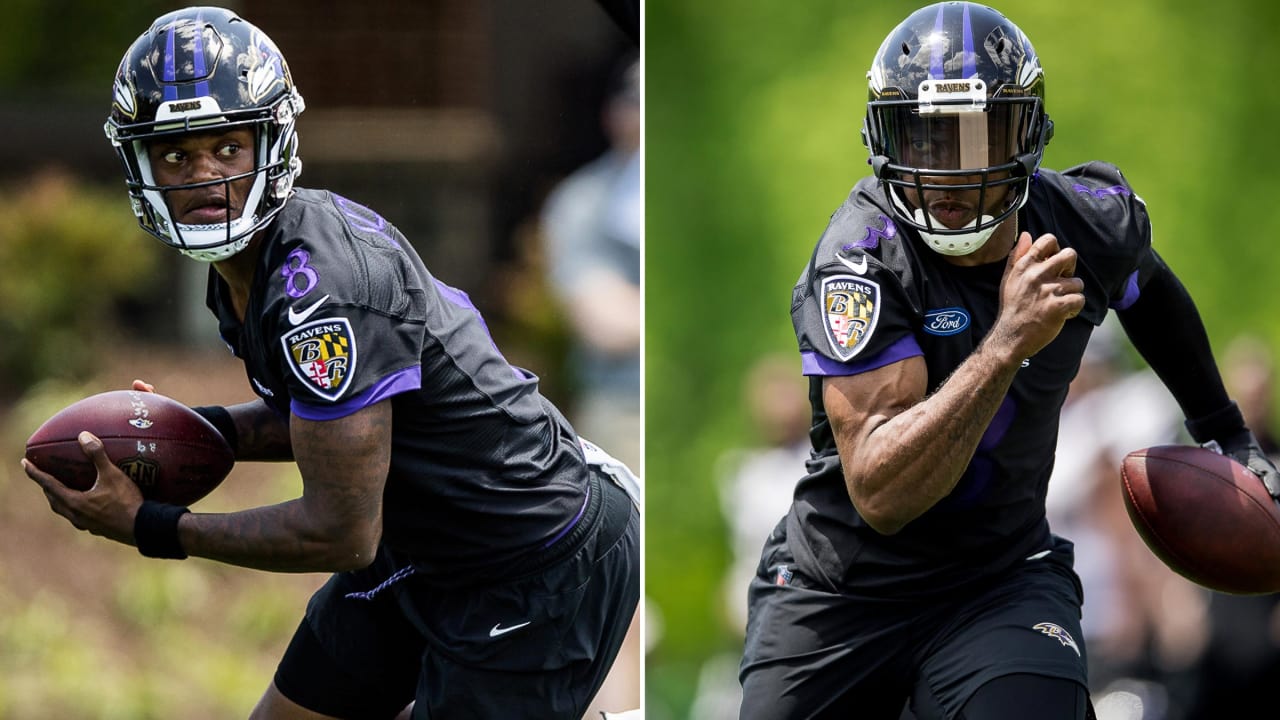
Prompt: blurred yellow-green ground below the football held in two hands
<box><xmin>0</xmin><ymin>380</ymin><xmax>314</xmax><ymax>720</ymax></box>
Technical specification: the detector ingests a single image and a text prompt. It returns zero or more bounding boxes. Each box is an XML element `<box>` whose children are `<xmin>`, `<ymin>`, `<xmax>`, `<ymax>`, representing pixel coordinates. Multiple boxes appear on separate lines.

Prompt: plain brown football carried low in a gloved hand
<box><xmin>1120</xmin><ymin>445</ymin><xmax>1280</xmax><ymax>594</ymax></box>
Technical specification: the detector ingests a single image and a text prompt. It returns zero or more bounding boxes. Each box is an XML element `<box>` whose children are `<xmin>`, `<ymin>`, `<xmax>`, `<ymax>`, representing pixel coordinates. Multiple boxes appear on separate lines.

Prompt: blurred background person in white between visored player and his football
<box><xmin>1046</xmin><ymin>318</ymin><xmax>1208</xmax><ymax>720</ymax></box>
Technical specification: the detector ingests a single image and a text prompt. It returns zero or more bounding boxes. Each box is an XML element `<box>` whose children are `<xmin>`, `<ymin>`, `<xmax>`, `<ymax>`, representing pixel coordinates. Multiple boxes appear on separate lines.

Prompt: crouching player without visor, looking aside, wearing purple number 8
<box><xmin>24</xmin><ymin>8</ymin><xmax>640</xmax><ymax>720</ymax></box>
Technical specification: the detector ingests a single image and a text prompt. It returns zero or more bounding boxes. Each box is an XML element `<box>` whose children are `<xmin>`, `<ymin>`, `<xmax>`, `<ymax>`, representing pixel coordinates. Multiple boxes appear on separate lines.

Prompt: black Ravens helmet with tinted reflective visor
<box><xmin>863</xmin><ymin>3</ymin><xmax>1053</xmax><ymax>255</ymax></box>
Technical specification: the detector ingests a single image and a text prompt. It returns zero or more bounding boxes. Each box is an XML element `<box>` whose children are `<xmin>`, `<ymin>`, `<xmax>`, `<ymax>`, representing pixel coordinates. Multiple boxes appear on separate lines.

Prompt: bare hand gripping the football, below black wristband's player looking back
<box><xmin>22</xmin><ymin>432</ymin><xmax>142</xmax><ymax>544</ymax></box>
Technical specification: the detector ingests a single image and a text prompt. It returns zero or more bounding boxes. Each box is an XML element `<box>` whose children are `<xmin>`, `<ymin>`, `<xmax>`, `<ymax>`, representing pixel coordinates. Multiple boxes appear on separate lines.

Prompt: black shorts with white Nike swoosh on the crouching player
<box><xmin>275</xmin><ymin>469</ymin><xmax>640</xmax><ymax>720</ymax></box>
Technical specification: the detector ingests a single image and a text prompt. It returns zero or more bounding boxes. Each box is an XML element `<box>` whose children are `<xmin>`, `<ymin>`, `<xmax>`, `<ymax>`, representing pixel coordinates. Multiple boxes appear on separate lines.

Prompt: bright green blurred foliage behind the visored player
<box><xmin>645</xmin><ymin>0</ymin><xmax>1280</xmax><ymax>720</ymax></box>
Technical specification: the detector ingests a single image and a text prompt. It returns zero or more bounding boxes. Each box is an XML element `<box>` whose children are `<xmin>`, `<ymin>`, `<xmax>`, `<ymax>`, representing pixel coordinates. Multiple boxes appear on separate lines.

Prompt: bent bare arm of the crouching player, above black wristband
<box><xmin>178</xmin><ymin>401</ymin><xmax>392</xmax><ymax>573</ymax></box>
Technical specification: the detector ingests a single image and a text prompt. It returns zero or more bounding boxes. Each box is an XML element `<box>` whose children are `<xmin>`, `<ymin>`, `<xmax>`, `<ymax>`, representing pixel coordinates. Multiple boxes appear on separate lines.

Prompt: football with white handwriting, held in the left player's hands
<box><xmin>27</xmin><ymin>389</ymin><xmax>236</xmax><ymax>505</ymax></box>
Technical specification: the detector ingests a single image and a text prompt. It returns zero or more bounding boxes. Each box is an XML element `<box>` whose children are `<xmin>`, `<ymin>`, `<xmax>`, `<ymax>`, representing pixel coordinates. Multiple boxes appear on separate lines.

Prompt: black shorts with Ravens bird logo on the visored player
<box><xmin>741</xmin><ymin>521</ymin><xmax>1088</xmax><ymax>720</ymax></box>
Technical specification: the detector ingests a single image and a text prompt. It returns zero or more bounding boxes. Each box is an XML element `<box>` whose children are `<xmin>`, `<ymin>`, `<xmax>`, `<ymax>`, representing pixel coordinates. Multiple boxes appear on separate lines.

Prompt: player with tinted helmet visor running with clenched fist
<box><xmin>741</xmin><ymin>3</ymin><xmax>1280</xmax><ymax>720</ymax></box>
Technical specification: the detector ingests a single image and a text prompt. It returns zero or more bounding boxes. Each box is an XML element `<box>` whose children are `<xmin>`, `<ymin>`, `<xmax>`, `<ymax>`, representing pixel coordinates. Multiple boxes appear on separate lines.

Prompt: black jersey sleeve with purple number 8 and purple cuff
<box><xmin>268</xmin><ymin>196</ymin><xmax>425</xmax><ymax>420</ymax></box>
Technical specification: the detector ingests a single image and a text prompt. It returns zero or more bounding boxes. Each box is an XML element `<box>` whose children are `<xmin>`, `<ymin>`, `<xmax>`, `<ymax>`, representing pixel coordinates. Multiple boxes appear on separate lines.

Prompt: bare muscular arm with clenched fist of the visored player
<box><xmin>823</xmin><ymin>233</ymin><xmax>1084</xmax><ymax>534</ymax></box>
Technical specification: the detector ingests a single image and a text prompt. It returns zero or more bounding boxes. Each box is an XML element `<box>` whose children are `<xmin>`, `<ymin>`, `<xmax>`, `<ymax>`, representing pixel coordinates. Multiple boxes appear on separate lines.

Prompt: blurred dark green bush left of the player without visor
<box><xmin>0</xmin><ymin>172</ymin><xmax>164</xmax><ymax>401</ymax></box>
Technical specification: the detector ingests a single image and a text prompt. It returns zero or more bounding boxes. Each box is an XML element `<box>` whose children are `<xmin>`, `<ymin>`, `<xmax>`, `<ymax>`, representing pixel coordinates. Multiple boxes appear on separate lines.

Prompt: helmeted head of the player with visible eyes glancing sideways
<box><xmin>104</xmin><ymin>9</ymin><xmax>306</xmax><ymax>263</ymax></box>
